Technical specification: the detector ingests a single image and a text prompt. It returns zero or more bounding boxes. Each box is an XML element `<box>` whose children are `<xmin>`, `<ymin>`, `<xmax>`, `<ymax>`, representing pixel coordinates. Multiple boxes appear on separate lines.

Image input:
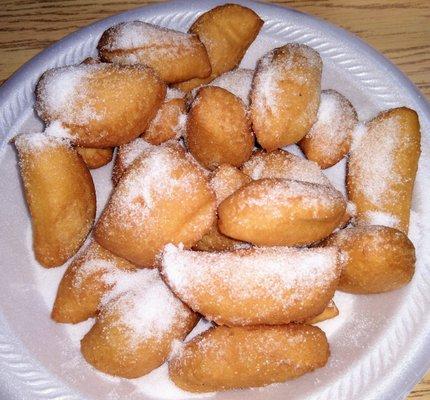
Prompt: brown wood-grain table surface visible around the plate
<box><xmin>0</xmin><ymin>0</ymin><xmax>430</xmax><ymax>400</ymax></box>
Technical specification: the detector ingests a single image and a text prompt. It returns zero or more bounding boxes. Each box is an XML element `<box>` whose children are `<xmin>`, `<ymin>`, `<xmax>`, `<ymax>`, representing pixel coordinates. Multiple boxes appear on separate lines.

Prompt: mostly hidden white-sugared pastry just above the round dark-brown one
<box><xmin>190</xmin><ymin>68</ymin><xmax>254</xmax><ymax>107</ymax></box>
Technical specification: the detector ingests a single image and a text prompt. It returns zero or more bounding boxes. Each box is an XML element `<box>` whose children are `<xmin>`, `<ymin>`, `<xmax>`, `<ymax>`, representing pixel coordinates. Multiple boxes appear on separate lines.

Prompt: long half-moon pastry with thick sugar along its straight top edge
<box><xmin>160</xmin><ymin>244</ymin><xmax>341</xmax><ymax>326</ymax></box>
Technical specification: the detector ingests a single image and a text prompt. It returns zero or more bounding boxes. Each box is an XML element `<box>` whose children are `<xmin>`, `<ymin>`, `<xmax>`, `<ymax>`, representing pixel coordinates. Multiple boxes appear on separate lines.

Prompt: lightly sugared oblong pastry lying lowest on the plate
<box><xmin>169</xmin><ymin>324</ymin><xmax>330</xmax><ymax>392</ymax></box>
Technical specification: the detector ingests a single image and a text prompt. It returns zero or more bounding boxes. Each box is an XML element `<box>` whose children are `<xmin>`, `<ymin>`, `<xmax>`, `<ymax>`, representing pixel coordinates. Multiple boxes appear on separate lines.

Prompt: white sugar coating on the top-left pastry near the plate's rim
<box><xmin>101</xmin><ymin>21</ymin><xmax>192</xmax><ymax>51</ymax></box>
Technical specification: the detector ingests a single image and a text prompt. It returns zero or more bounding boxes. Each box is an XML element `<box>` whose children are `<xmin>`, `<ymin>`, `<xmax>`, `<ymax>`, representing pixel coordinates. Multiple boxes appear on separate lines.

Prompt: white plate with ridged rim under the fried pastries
<box><xmin>0</xmin><ymin>0</ymin><xmax>430</xmax><ymax>400</ymax></box>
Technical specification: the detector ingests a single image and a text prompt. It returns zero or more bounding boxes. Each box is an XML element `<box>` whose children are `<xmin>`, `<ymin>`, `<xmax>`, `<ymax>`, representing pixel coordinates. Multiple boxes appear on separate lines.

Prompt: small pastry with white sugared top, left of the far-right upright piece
<box><xmin>299</xmin><ymin>89</ymin><xmax>358</xmax><ymax>169</ymax></box>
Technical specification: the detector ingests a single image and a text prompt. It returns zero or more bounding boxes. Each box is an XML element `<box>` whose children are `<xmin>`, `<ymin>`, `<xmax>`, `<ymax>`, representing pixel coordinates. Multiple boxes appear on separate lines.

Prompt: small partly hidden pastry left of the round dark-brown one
<box><xmin>142</xmin><ymin>89</ymin><xmax>187</xmax><ymax>144</ymax></box>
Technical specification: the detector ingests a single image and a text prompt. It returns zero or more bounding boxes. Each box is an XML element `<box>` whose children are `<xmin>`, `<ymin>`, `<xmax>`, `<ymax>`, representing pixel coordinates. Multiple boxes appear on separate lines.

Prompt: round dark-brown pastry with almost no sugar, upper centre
<box><xmin>186</xmin><ymin>86</ymin><xmax>254</xmax><ymax>169</ymax></box>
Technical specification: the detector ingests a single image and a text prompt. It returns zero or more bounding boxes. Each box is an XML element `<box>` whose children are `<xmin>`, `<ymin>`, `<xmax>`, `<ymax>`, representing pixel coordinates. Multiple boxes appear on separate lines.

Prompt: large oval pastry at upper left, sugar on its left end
<box><xmin>35</xmin><ymin>63</ymin><xmax>166</xmax><ymax>148</ymax></box>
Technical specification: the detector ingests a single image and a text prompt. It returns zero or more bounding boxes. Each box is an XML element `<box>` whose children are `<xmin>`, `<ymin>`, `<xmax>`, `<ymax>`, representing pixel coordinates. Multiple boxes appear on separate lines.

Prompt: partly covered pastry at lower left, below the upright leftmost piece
<box><xmin>51</xmin><ymin>241</ymin><xmax>137</xmax><ymax>324</ymax></box>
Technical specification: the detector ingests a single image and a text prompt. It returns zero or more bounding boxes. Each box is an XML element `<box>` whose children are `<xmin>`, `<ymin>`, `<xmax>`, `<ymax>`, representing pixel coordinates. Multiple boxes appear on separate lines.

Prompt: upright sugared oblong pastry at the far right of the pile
<box><xmin>347</xmin><ymin>107</ymin><xmax>421</xmax><ymax>234</ymax></box>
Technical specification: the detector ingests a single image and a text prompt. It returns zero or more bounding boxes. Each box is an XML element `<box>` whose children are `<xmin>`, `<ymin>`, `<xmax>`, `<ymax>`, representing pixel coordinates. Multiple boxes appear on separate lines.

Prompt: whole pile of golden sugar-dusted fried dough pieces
<box><xmin>14</xmin><ymin>4</ymin><xmax>420</xmax><ymax>392</ymax></box>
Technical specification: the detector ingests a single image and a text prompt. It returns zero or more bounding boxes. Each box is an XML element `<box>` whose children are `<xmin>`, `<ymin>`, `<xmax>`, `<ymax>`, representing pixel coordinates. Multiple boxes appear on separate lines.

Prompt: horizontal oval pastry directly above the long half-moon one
<box><xmin>218</xmin><ymin>179</ymin><xmax>346</xmax><ymax>246</ymax></box>
